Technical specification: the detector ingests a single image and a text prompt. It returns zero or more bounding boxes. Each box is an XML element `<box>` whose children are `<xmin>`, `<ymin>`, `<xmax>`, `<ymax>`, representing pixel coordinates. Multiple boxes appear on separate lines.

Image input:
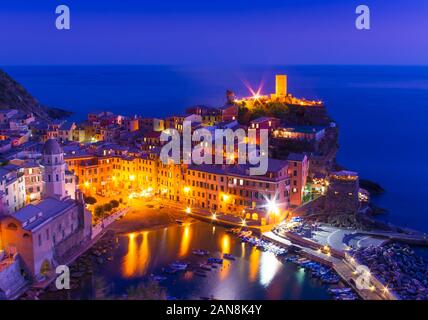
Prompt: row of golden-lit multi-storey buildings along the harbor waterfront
<box><xmin>66</xmin><ymin>148</ymin><xmax>290</xmax><ymax>223</ymax></box>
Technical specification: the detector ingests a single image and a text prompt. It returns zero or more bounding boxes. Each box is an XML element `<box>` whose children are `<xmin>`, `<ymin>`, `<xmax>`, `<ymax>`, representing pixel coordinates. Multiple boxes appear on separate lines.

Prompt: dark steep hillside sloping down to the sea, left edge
<box><xmin>0</xmin><ymin>69</ymin><xmax>72</xmax><ymax>120</ymax></box>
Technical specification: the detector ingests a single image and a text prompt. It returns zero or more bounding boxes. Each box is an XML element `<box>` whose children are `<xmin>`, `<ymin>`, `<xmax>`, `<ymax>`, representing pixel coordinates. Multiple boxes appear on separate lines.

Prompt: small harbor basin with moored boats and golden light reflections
<box><xmin>38</xmin><ymin>221</ymin><xmax>332</xmax><ymax>300</ymax></box>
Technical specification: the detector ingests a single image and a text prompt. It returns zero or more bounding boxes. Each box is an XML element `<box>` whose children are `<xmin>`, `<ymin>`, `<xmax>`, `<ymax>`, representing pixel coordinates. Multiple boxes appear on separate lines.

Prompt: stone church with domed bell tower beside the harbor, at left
<box><xmin>0</xmin><ymin>139</ymin><xmax>92</xmax><ymax>280</ymax></box>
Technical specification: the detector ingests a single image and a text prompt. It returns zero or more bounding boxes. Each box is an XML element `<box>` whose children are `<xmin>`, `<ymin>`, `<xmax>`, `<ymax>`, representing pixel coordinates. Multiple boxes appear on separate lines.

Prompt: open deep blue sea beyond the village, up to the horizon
<box><xmin>4</xmin><ymin>66</ymin><xmax>428</xmax><ymax>231</ymax></box>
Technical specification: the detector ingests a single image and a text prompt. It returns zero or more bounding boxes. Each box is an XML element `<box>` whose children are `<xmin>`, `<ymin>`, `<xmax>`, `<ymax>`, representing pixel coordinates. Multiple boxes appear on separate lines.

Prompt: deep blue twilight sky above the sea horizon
<box><xmin>0</xmin><ymin>0</ymin><xmax>428</xmax><ymax>65</ymax></box>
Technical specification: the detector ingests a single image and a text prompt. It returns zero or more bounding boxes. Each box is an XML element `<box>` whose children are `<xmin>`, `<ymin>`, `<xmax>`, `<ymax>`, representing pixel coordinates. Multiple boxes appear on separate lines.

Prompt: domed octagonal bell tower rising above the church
<box><xmin>41</xmin><ymin>139</ymin><xmax>66</xmax><ymax>199</ymax></box>
